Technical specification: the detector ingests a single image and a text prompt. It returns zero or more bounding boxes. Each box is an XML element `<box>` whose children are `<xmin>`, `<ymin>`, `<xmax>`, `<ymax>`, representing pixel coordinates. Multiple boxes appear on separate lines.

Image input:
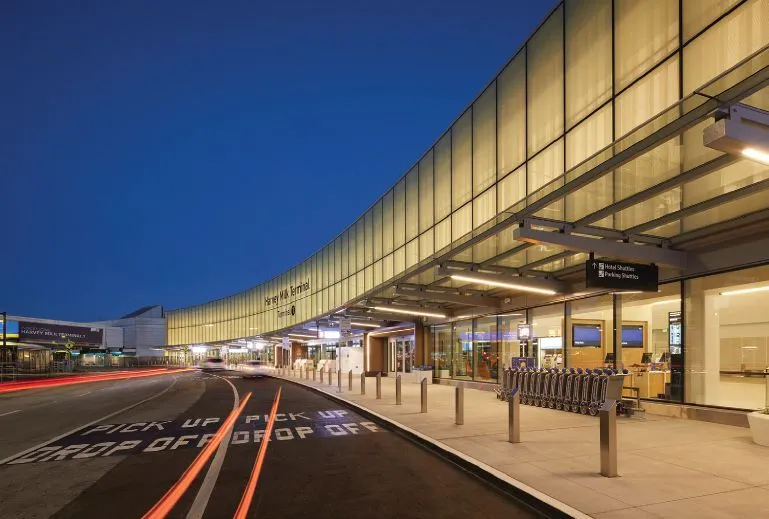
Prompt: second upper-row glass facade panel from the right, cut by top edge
<box><xmin>614</xmin><ymin>0</ymin><xmax>678</xmax><ymax>91</ymax></box>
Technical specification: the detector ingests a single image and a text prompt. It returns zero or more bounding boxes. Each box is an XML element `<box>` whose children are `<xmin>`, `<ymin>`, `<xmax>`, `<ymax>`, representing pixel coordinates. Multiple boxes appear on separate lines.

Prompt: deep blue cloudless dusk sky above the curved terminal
<box><xmin>0</xmin><ymin>0</ymin><xmax>555</xmax><ymax>321</ymax></box>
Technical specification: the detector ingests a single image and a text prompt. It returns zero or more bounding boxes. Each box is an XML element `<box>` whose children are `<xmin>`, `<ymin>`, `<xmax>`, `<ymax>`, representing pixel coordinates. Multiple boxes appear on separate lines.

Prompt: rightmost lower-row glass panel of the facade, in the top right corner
<box><xmin>683</xmin><ymin>0</ymin><xmax>769</xmax><ymax>95</ymax></box>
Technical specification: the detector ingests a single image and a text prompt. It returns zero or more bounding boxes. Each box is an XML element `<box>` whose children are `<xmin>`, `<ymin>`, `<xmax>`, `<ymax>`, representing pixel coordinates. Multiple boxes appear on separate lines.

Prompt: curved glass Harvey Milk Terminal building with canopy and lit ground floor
<box><xmin>167</xmin><ymin>0</ymin><xmax>769</xmax><ymax>418</ymax></box>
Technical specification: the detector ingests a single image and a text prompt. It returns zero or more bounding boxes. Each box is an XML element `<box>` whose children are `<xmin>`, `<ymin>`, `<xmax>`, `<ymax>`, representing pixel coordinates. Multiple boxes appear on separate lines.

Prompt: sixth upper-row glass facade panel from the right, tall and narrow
<box><xmin>473</xmin><ymin>83</ymin><xmax>497</xmax><ymax>196</ymax></box>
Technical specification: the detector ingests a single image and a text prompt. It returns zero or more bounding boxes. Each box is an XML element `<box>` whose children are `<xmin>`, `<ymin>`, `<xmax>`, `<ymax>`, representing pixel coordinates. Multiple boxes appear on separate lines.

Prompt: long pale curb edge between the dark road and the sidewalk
<box><xmin>271</xmin><ymin>375</ymin><xmax>591</xmax><ymax>519</ymax></box>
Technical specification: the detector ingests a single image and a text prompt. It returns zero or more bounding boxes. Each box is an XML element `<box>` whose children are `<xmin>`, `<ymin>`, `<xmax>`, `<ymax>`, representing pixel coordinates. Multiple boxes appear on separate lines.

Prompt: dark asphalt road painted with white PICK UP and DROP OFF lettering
<box><xmin>0</xmin><ymin>372</ymin><xmax>537</xmax><ymax>519</ymax></box>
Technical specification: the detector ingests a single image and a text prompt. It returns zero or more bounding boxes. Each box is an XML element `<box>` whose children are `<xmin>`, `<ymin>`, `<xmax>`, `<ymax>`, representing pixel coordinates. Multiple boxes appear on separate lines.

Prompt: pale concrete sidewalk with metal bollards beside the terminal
<box><xmin>276</xmin><ymin>373</ymin><xmax>769</xmax><ymax>519</ymax></box>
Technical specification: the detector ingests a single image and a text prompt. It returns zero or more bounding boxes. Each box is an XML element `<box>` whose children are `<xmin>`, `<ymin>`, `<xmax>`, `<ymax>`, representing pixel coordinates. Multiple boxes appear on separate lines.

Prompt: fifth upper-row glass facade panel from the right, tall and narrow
<box><xmin>497</xmin><ymin>52</ymin><xmax>526</xmax><ymax>177</ymax></box>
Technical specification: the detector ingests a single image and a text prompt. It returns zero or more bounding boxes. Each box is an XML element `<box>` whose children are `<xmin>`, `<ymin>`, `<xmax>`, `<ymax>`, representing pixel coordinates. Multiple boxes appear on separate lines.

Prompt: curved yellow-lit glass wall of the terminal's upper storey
<box><xmin>168</xmin><ymin>0</ymin><xmax>769</xmax><ymax>350</ymax></box>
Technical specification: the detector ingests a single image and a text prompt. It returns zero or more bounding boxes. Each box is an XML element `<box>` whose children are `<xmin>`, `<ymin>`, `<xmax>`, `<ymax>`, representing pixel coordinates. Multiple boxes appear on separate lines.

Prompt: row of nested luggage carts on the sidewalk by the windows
<box><xmin>497</xmin><ymin>368</ymin><xmax>632</xmax><ymax>416</ymax></box>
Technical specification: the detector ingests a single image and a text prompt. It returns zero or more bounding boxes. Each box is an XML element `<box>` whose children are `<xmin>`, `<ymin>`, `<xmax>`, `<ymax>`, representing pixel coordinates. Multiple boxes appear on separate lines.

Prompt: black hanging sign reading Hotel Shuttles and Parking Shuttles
<box><xmin>585</xmin><ymin>260</ymin><xmax>659</xmax><ymax>292</ymax></box>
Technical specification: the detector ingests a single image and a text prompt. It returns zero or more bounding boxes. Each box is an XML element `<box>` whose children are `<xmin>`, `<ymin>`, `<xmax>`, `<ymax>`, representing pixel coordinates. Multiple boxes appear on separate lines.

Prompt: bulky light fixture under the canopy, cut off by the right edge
<box><xmin>702</xmin><ymin>103</ymin><xmax>769</xmax><ymax>165</ymax></box>
